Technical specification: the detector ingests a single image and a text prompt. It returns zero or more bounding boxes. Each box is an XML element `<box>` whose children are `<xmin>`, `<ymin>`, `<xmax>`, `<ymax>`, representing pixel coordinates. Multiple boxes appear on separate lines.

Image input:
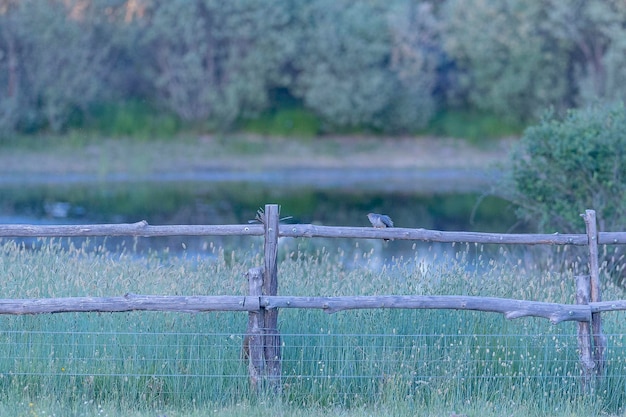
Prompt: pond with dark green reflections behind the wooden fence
<box><xmin>0</xmin><ymin>169</ymin><xmax>523</xmax><ymax>257</ymax></box>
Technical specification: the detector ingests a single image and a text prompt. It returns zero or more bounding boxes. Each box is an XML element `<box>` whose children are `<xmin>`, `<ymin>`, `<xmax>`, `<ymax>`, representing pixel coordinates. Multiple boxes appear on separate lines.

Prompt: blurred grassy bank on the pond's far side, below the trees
<box><xmin>0</xmin><ymin>134</ymin><xmax>511</xmax><ymax>180</ymax></box>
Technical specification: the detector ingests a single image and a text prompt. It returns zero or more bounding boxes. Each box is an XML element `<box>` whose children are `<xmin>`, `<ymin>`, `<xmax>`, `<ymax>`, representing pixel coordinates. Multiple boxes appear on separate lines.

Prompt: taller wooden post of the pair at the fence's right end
<box><xmin>581</xmin><ymin>210</ymin><xmax>606</xmax><ymax>376</ymax></box>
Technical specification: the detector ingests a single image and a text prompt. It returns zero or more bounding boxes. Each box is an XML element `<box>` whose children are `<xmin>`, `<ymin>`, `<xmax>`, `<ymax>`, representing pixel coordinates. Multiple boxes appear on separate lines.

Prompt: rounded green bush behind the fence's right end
<box><xmin>501</xmin><ymin>99</ymin><xmax>626</xmax><ymax>233</ymax></box>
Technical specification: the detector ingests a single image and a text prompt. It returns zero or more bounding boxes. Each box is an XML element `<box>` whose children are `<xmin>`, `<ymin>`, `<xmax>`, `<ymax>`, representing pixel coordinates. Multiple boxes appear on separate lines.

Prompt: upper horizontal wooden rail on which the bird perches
<box><xmin>0</xmin><ymin>220</ymin><xmax>626</xmax><ymax>246</ymax></box>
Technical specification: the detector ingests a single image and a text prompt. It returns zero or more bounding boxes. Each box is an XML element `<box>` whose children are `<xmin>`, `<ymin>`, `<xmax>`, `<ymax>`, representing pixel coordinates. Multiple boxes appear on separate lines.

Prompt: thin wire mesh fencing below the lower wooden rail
<box><xmin>0</xmin><ymin>324</ymin><xmax>626</xmax><ymax>404</ymax></box>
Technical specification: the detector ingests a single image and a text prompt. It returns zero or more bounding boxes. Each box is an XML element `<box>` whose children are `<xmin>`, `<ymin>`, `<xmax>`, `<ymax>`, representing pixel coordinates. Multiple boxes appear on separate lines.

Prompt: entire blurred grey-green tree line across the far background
<box><xmin>0</xmin><ymin>0</ymin><xmax>626</xmax><ymax>133</ymax></box>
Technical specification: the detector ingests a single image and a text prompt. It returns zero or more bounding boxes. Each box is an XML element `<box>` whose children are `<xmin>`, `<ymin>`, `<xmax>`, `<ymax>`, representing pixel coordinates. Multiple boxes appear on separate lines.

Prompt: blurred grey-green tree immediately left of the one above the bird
<box><xmin>140</xmin><ymin>0</ymin><xmax>286</xmax><ymax>125</ymax></box>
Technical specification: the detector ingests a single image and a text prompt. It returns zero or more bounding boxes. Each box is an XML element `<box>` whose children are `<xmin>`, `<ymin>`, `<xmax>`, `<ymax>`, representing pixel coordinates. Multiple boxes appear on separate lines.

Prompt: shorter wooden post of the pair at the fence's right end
<box><xmin>576</xmin><ymin>275</ymin><xmax>596</xmax><ymax>392</ymax></box>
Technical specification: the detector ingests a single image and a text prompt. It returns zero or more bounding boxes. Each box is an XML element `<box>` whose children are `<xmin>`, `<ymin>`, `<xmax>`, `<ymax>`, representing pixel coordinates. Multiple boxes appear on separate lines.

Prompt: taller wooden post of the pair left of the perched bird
<box><xmin>263</xmin><ymin>204</ymin><xmax>282</xmax><ymax>392</ymax></box>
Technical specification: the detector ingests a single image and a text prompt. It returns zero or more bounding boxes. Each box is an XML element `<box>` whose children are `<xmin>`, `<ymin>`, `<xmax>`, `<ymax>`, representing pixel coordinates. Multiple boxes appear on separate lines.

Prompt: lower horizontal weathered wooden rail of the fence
<box><xmin>0</xmin><ymin>294</ymin><xmax>604</xmax><ymax>324</ymax></box>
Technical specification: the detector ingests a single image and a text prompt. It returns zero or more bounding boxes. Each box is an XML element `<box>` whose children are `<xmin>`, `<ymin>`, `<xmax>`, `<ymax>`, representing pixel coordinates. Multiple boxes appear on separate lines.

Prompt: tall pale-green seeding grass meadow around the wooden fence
<box><xmin>0</xmin><ymin>240</ymin><xmax>626</xmax><ymax>417</ymax></box>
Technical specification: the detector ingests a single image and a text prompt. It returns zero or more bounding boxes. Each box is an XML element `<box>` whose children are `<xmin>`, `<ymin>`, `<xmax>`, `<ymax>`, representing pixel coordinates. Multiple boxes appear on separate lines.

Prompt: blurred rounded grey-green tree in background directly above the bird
<box><xmin>291</xmin><ymin>0</ymin><xmax>442</xmax><ymax>132</ymax></box>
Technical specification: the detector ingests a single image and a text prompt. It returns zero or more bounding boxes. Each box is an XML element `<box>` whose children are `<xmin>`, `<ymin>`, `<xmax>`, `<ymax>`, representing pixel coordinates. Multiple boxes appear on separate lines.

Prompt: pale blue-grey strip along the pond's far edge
<box><xmin>0</xmin><ymin>168</ymin><xmax>499</xmax><ymax>192</ymax></box>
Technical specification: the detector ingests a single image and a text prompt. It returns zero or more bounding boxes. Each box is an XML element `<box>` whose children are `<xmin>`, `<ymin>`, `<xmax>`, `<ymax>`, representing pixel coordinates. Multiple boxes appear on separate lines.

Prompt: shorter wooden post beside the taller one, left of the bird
<box><xmin>242</xmin><ymin>268</ymin><xmax>265</xmax><ymax>392</ymax></box>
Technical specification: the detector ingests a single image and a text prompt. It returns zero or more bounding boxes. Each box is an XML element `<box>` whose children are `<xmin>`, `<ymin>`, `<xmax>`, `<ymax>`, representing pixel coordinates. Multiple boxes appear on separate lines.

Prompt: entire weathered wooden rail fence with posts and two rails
<box><xmin>0</xmin><ymin>204</ymin><xmax>626</xmax><ymax>390</ymax></box>
